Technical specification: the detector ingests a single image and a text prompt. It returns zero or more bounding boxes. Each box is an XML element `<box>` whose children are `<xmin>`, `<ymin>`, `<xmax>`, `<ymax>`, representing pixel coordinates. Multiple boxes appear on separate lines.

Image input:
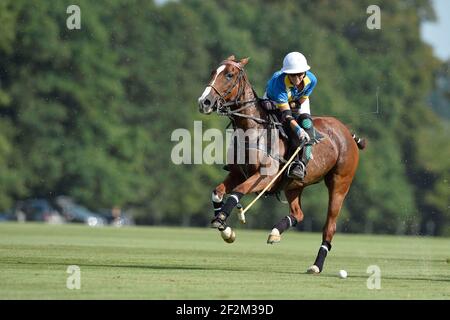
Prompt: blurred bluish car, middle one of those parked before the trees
<box><xmin>54</xmin><ymin>196</ymin><xmax>107</xmax><ymax>227</ymax></box>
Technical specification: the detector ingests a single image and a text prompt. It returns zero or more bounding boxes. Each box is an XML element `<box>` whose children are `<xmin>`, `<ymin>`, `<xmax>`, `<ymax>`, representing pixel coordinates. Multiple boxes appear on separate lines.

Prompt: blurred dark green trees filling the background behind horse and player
<box><xmin>0</xmin><ymin>0</ymin><xmax>450</xmax><ymax>235</ymax></box>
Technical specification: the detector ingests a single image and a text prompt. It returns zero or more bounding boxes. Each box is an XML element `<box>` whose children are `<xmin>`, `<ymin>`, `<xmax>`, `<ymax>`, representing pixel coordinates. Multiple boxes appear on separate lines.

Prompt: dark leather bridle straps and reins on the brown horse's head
<box><xmin>207</xmin><ymin>60</ymin><xmax>268</xmax><ymax>123</ymax></box>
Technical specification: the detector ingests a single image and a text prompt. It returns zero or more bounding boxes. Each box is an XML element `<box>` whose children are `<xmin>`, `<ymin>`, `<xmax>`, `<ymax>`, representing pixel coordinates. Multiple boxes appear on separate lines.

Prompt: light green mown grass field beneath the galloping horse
<box><xmin>0</xmin><ymin>223</ymin><xmax>450</xmax><ymax>300</ymax></box>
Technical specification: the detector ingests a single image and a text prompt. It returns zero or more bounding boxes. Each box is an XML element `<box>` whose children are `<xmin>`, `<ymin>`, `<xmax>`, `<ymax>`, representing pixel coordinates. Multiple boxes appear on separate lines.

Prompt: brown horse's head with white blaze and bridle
<box><xmin>198</xmin><ymin>56</ymin><xmax>248</xmax><ymax>114</ymax></box>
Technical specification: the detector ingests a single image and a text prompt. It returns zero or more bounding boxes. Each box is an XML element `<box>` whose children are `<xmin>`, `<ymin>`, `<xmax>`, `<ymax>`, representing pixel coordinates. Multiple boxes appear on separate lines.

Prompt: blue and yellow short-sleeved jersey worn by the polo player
<box><xmin>266</xmin><ymin>71</ymin><xmax>317</xmax><ymax>110</ymax></box>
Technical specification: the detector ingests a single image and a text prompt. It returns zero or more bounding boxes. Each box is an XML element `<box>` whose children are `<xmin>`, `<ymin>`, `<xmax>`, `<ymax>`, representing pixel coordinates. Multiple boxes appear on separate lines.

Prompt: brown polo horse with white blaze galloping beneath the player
<box><xmin>198</xmin><ymin>56</ymin><xmax>365</xmax><ymax>273</ymax></box>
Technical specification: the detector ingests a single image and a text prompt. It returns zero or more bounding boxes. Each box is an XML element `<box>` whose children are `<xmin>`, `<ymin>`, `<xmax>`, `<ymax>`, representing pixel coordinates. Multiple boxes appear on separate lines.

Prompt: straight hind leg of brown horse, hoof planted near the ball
<box><xmin>308</xmin><ymin>174</ymin><xmax>353</xmax><ymax>273</ymax></box>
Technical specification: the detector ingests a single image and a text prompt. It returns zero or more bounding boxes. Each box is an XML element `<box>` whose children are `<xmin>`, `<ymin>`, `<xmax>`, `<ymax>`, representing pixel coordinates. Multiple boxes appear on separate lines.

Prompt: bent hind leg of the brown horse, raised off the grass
<box><xmin>267</xmin><ymin>189</ymin><xmax>303</xmax><ymax>244</ymax></box>
